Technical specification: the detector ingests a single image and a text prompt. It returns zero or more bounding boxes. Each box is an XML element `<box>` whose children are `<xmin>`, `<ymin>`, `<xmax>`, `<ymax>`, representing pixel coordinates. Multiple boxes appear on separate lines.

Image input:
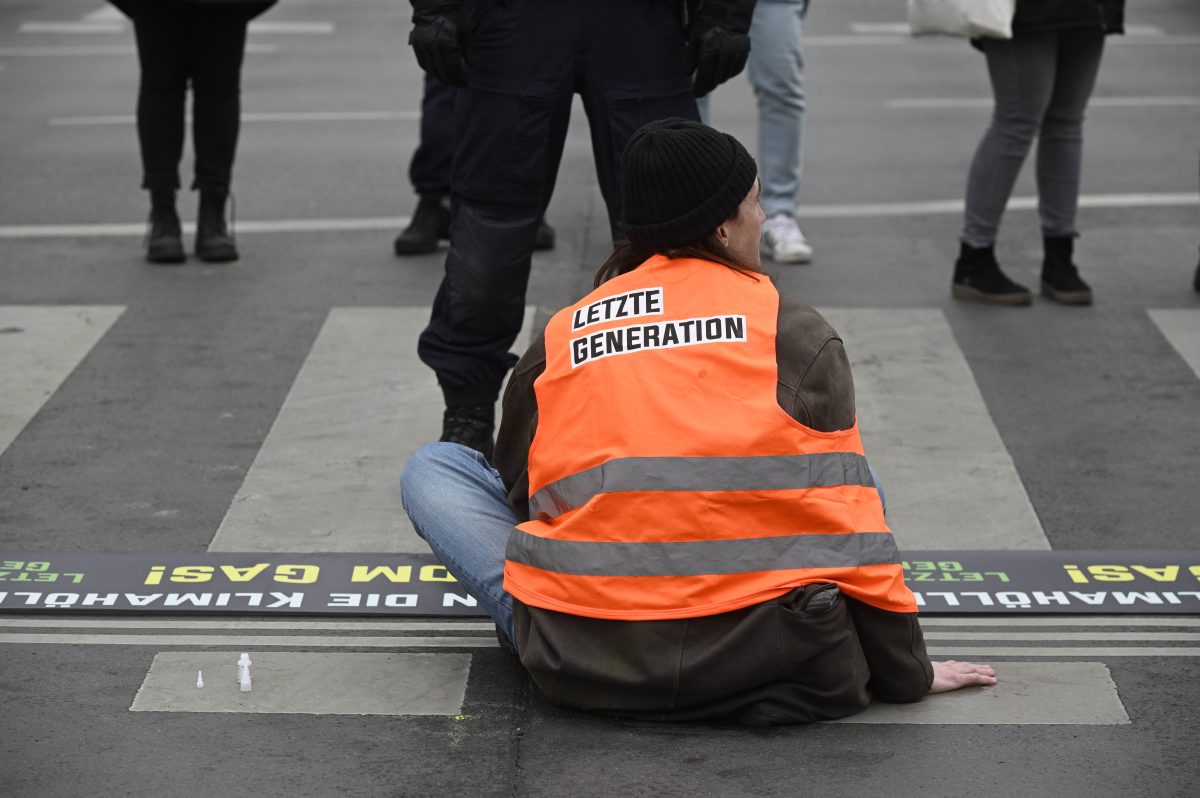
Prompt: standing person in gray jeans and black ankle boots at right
<box><xmin>952</xmin><ymin>0</ymin><xmax>1124</xmax><ymax>305</ymax></box>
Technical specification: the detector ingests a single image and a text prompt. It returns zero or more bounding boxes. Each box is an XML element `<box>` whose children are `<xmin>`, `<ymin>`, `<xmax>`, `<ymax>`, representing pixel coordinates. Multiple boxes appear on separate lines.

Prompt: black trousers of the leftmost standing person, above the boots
<box><xmin>119</xmin><ymin>0</ymin><xmax>271</xmax><ymax>193</ymax></box>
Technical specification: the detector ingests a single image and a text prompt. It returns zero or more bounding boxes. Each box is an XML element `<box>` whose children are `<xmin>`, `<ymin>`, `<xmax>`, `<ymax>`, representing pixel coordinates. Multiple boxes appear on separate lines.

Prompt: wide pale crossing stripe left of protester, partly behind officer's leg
<box><xmin>209</xmin><ymin>307</ymin><xmax>534</xmax><ymax>553</ymax></box>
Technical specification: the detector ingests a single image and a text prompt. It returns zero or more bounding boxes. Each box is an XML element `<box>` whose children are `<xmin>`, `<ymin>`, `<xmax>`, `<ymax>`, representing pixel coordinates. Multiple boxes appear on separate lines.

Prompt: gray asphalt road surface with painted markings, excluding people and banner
<box><xmin>0</xmin><ymin>0</ymin><xmax>1200</xmax><ymax>798</ymax></box>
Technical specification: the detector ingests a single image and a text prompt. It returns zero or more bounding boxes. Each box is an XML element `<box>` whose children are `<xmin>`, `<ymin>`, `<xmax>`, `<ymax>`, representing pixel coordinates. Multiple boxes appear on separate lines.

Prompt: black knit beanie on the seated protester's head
<box><xmin>620</xmin><ymin>119</ymin><xmax>758</xmax><ymax>250</ymax></box>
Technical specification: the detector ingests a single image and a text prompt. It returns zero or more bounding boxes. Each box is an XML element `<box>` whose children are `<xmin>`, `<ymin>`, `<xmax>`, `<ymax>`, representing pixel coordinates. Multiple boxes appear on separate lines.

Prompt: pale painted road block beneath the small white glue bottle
<box><xmin>130</xmin><ymin>652</ymin><xmax>470</xmax><ymax>715</ymax></box>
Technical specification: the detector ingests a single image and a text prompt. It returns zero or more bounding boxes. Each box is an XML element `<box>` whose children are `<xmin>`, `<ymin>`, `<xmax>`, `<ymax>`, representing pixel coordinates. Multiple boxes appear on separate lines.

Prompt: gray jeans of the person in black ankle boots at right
<box><xmin>961</xmin><ymin>29</ymin><xmax>1104</xmax><ymax>247</ymax></box>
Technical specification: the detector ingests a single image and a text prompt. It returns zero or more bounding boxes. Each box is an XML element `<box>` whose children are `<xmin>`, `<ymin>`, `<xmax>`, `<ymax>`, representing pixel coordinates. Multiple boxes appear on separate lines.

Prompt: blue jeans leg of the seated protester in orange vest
<box><xmin>400</xmin><ymin>443</ymin><xmax>520</xmax><ymax>641</ymax></box>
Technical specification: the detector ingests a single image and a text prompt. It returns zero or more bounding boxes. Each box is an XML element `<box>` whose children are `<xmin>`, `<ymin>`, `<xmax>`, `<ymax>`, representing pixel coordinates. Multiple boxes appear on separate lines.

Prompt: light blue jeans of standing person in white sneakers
<box><xmin>696</xmin><ymin>0</ymin><xmax>809</xmax><ymax>217</ymax></box>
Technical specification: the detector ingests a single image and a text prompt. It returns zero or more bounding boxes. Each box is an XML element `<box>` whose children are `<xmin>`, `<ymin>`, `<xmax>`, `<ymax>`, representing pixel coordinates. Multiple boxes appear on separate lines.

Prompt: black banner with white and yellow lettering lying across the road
<box><xmin>0</xmin><ymin>550</ymin><xmax>1200</xmax><ymax>617</ymax></box>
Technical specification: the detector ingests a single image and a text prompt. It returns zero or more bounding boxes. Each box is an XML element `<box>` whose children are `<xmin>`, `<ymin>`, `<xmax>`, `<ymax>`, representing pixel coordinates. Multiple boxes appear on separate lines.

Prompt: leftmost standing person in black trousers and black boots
<box><xmin>112</xmin><ymin>0</ymin><xmax>275</xmax><ymax>263</ymax></box>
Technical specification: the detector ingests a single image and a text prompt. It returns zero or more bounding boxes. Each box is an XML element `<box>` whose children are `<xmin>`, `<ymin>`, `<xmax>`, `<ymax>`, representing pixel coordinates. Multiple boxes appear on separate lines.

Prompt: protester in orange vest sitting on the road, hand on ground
<box><xmin>401</xmin><ymin>119</ymin><xmax>996</xmax><ymax>725</ymax></box>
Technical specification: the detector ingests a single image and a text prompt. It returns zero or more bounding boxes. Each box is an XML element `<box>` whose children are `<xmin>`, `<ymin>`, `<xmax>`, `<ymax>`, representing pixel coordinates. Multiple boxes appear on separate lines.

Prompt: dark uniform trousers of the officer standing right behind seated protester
<box><xmin>418</xmin><ymin>0</ymin><xmax>698</xmax><ymax>406</ymax></box>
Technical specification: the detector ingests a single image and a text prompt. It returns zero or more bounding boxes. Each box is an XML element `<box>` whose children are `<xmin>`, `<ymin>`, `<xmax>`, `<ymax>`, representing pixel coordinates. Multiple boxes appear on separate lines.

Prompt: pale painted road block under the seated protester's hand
<box><xmin>833</xmin><ymin>662</ymin><xmax>1129</xmax><ymax>726</ymax></box>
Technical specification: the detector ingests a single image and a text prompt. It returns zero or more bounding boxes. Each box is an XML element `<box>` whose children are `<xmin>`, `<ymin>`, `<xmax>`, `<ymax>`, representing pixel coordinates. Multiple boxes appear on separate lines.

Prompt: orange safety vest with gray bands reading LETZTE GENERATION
<box><xmin>504</xmin><ymin>256</ymin><xmax>917</xmax><ymax>620</ymax></box>
